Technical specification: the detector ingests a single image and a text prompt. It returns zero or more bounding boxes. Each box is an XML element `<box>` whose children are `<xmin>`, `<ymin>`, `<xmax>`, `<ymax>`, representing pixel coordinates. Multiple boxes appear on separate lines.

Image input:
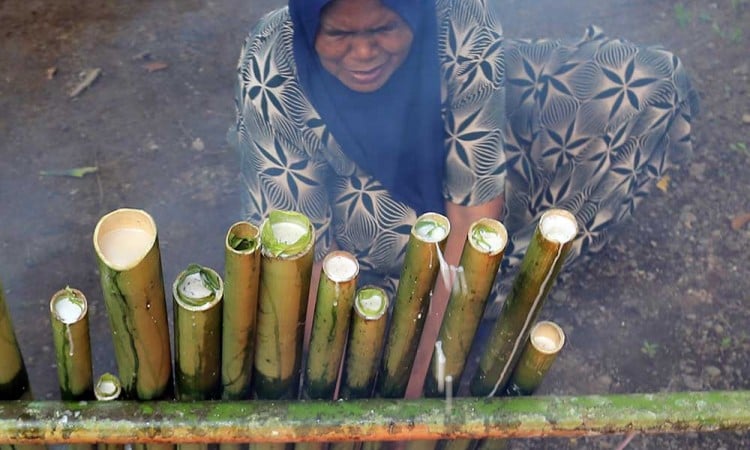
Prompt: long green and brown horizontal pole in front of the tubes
<box><xmin>0</xmin><ymin>391</ymin><xmax>750</xmax><ymax>444</ymax></box>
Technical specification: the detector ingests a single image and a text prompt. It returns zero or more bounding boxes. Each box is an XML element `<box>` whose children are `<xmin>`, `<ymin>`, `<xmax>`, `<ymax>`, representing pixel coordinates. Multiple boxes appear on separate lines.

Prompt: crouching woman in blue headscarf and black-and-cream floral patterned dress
<box><xmin>235</xmin><ymin>0</ymin><xmax>694</xmax><ymax>394</ymax></box>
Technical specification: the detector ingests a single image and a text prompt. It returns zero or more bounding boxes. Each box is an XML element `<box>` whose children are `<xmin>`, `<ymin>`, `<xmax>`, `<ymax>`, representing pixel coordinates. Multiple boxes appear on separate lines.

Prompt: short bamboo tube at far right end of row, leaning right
<box><xmin>505</xmin><ymin>321</ymin><xmax>565</xmax><ymax>396</ymax></box>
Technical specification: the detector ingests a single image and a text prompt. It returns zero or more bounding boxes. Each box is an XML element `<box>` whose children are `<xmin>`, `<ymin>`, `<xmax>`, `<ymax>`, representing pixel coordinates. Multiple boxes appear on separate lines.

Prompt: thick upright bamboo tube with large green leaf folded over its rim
<box><xmin>253</xmin><ymin>211</ymin><xmax>315</xmax><ymax>400</ymax></box>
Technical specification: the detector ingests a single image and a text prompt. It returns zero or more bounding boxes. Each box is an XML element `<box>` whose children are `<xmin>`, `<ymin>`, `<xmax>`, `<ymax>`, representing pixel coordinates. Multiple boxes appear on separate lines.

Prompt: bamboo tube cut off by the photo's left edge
<box><xmin>0</xmin><ymin>283</ymin><xmax>31</xmax><ymax>401</ymax></box>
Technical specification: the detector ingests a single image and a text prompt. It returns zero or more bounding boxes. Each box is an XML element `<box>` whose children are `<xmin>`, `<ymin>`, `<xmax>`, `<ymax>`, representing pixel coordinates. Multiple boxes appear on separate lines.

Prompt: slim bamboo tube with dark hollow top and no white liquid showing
<box><xmin>221</xmin><ymin>222</ymin><xmax>260</xmax><ymax>400</ymax></box>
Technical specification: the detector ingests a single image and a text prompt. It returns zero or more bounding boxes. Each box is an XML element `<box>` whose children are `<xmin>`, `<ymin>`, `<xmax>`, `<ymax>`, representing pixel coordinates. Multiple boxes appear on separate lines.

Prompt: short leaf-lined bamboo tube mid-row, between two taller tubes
<box><xmin>340</xmin><ymin>286</ymin><xmax>389</xmax><ymax>399</ymax></box>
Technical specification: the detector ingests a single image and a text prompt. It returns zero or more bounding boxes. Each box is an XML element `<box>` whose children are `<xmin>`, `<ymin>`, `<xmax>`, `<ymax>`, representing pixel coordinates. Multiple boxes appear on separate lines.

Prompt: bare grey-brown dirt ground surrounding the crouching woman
<box><xmin>0</xmin><ymin>0</ymin><xmax>750</xmax><ymax>449</ymax></box>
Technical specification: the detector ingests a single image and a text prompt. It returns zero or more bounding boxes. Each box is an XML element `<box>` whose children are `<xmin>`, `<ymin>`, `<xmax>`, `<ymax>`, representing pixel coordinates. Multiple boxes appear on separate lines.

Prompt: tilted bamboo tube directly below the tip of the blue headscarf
<box><xmin>378</xmin><ymin>213</ymin><xmax>450</xmax><ymax>398</ymax></box>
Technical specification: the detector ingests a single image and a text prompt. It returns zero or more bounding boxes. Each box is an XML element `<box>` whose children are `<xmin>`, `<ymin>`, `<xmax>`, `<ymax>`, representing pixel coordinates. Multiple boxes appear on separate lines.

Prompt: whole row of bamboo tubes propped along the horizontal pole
<box><xmin>0</xmin><ymin>209</ymin><xmax>577</xmax><ymax>450</ymax></box>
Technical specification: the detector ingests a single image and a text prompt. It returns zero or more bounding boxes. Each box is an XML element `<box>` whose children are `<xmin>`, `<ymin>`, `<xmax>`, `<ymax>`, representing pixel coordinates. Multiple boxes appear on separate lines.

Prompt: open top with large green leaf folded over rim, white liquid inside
<box><xmin>260</xmin><ymin>211</ymin><xmax>315</xmax><ymax>259</ymax></box>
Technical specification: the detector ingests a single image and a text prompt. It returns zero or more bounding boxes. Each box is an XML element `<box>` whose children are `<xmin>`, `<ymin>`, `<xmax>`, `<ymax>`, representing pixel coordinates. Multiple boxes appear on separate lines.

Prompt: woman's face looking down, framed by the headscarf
<box><xmin>315</xmin><ymin>0</ymin><xmax>413</xmax><ymax>92</ymax></box>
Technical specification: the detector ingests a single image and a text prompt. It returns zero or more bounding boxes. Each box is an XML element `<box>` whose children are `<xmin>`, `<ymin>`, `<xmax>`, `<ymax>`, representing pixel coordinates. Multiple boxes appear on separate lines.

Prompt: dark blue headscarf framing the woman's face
<box><xmin>289</xmin><ymin>0</ymin><xmax>446</xmax><ymax>214</ymax></box>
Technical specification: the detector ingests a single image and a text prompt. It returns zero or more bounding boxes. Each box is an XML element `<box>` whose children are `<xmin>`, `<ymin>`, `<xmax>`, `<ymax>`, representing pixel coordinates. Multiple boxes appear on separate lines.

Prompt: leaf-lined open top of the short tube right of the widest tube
<box><xmin>172</xmin><ymin>264</ymin><xmax>224</xmax><ymax>311</ymax></box>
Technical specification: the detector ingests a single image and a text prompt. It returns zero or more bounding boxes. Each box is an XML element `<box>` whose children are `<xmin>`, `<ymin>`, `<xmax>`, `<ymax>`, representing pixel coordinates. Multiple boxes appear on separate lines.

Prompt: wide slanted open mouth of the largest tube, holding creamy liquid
<box><xmin>94</xmin><ymin>209</ymin><xmax>156</xmax><ymax>271</ymax></box>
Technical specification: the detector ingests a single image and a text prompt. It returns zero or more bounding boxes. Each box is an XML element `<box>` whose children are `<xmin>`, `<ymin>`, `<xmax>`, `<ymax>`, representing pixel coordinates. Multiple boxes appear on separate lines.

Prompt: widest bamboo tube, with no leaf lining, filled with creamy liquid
<box><xmin>94</xmin><ymin>209</ymin><xmax>172</xmax><ymax>400</ymax></box>
